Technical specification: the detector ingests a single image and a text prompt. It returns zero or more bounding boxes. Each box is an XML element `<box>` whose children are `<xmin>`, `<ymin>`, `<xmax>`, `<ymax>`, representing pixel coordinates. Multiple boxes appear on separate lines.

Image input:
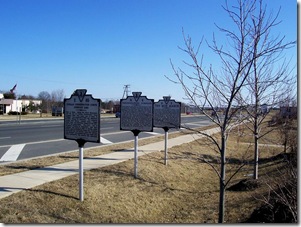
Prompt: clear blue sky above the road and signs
<box><xmin>0</xmin><ymin>0</ymin><xmax>297</xmax><ymax>102</ymax></box>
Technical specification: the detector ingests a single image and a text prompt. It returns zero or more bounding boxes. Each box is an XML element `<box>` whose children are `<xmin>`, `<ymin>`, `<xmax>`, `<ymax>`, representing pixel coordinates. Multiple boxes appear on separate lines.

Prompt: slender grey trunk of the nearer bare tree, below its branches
<box><xmin>218</xmin><ymin>136</ymin><xmax>226</xmax><ymax>223</ymax></box>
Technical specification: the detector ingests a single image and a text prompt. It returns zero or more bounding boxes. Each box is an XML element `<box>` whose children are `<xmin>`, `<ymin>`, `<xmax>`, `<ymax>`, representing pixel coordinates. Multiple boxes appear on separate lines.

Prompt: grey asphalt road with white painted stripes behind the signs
<box><xmin>0</xmin><ymin>116</ymin><xmax>210</xmax><ymax>163</ymax></box>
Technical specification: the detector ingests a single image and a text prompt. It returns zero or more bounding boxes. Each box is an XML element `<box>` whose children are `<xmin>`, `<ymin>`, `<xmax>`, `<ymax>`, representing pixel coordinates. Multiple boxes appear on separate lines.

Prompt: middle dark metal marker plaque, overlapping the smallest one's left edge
<box><xmin>120</xmin><ymin>92</ymin><xmax>154</xmax><ymax>132</ymax></box>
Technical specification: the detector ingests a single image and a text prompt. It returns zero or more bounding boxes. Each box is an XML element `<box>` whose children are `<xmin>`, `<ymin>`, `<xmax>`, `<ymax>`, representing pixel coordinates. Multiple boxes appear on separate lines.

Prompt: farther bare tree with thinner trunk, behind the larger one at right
<box><xmin>239</xmin><ymin>0</ymin><xmax>297</xmax><ymax>179</ymax></box>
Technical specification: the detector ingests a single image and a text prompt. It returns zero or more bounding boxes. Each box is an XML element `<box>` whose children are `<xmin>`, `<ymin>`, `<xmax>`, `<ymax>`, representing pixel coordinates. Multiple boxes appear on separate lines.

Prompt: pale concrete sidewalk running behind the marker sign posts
<box><xmin>0</xmin><ymin>128</ymin><xmax>218</xmax><ymax>199</ymax></box>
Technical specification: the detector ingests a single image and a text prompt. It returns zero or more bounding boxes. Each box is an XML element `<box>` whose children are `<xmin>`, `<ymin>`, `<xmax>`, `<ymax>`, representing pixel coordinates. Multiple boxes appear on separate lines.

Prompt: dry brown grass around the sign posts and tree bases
<box><xmin>0</xmin><ymin>119</ymin><xmax>288</xmax><ymax>224</ymax></box>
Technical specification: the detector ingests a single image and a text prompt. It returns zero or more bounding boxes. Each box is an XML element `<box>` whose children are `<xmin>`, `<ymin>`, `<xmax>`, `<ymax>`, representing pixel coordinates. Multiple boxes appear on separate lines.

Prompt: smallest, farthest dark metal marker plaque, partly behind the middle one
<box><xmin>154</xmin><ymin>96</ymin><xmax>181</xmax><ymax>128</ymax></box>
